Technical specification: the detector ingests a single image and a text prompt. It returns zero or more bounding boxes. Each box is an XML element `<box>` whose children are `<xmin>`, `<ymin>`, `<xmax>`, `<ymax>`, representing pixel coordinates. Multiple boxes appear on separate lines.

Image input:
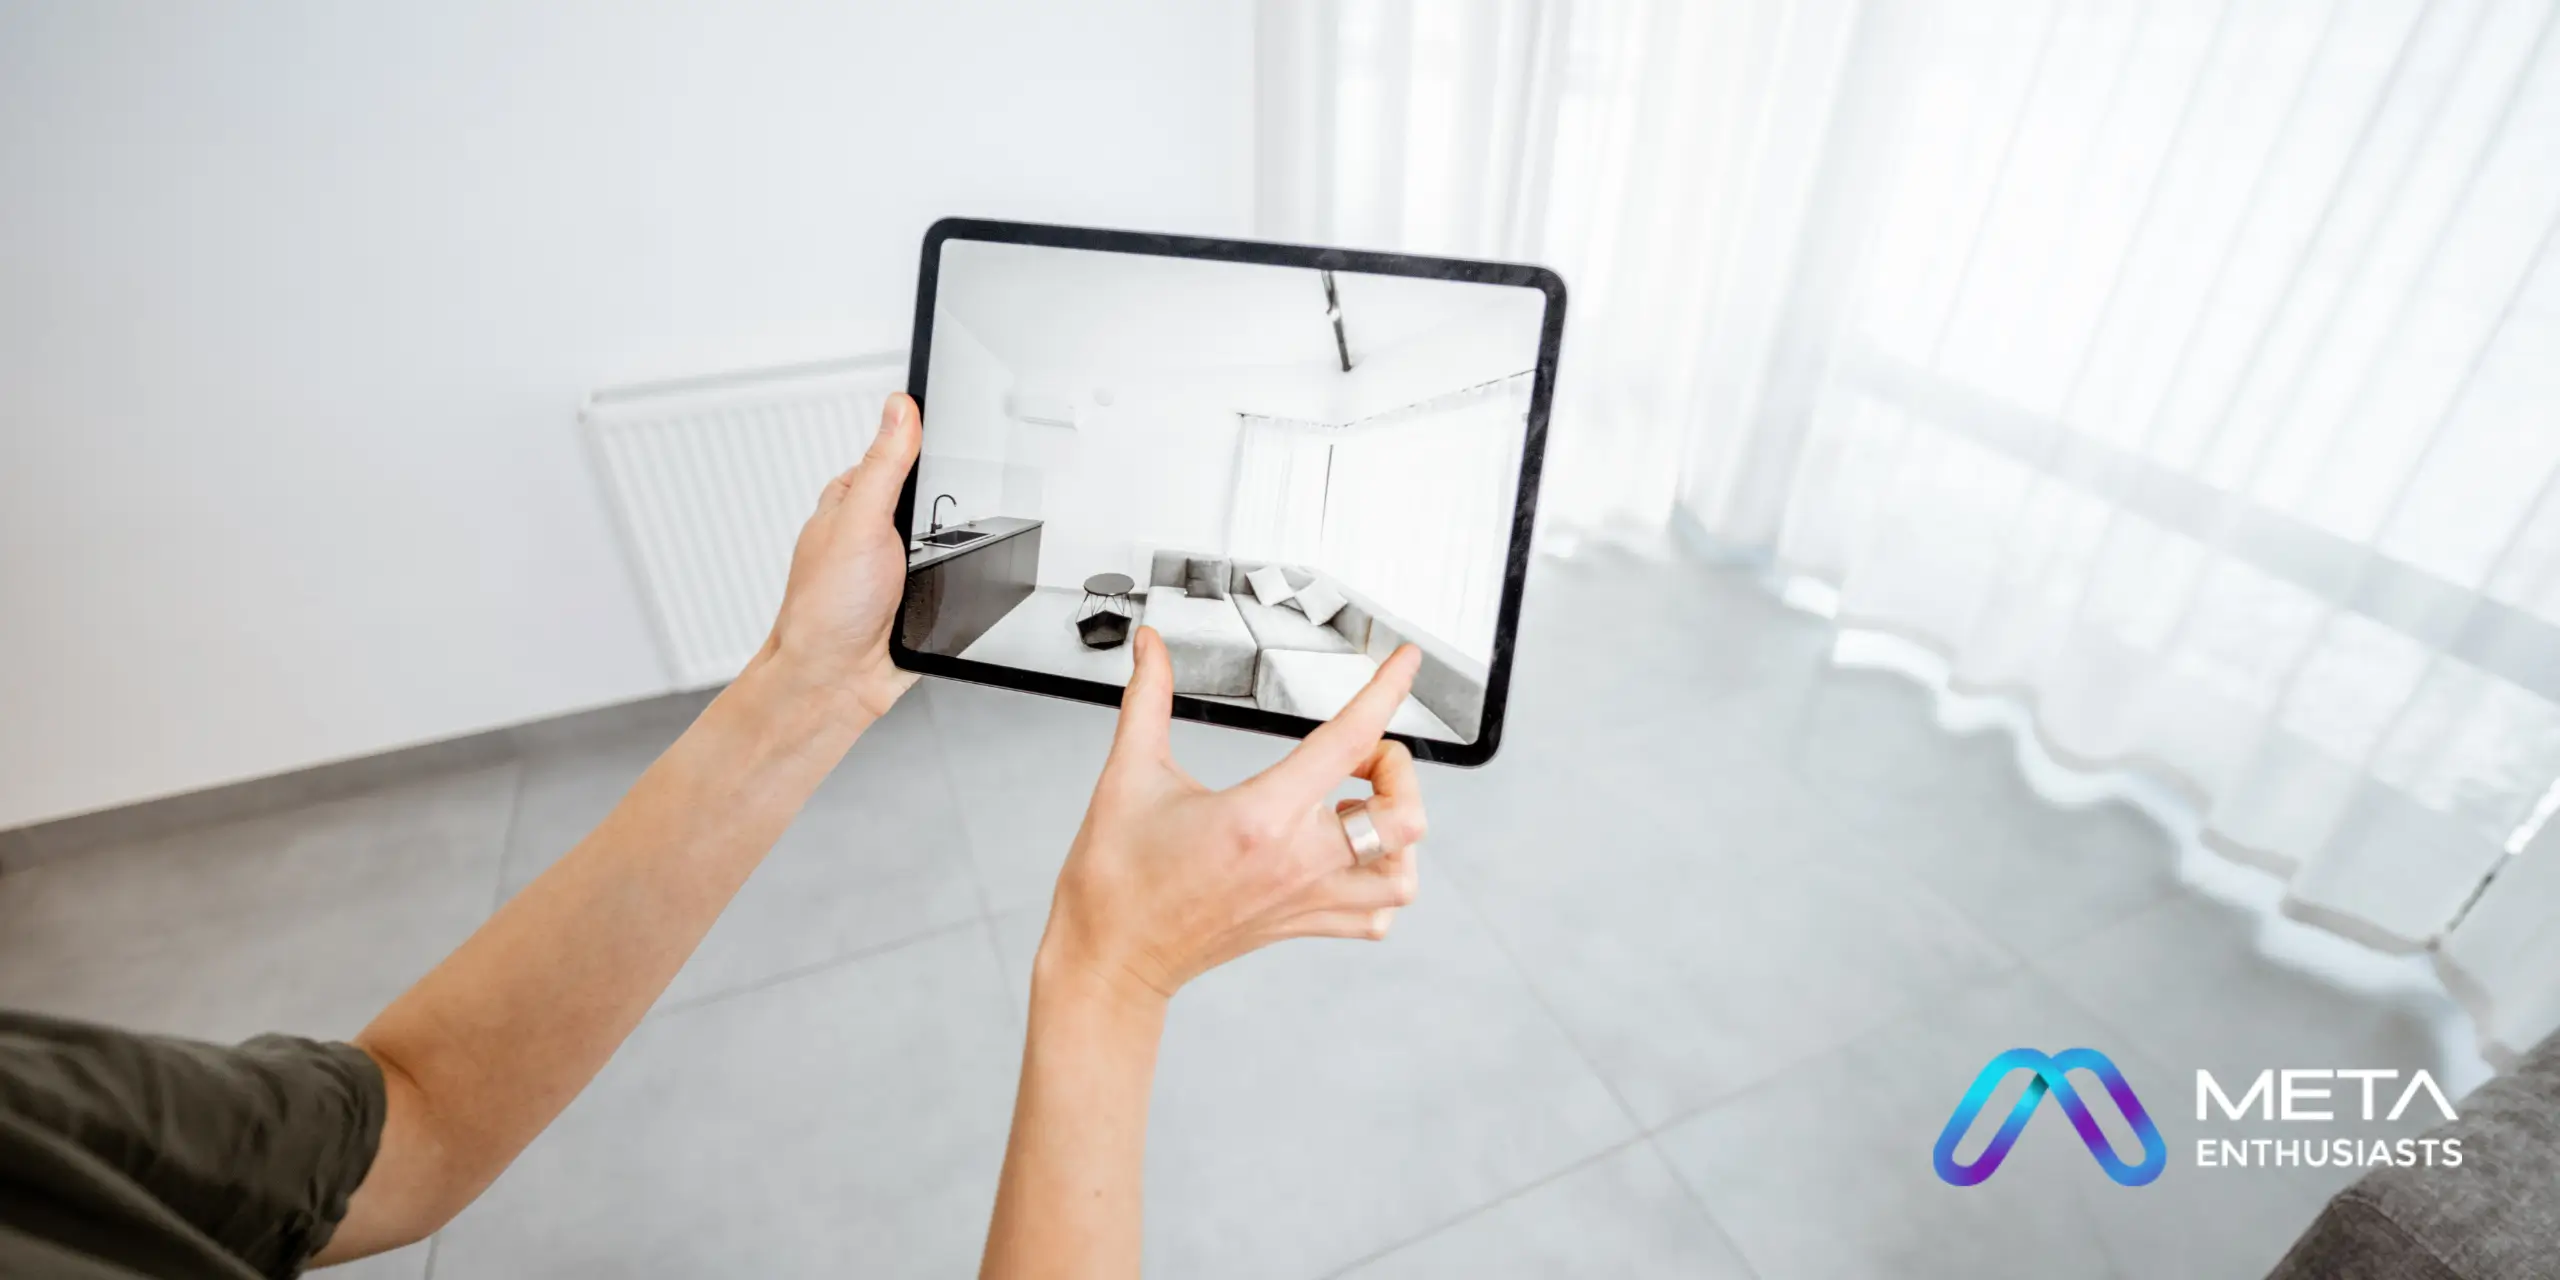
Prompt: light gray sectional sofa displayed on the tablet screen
<box><xmin>1142</xmin><ymin>550</ymin><xmax>1485</xmax><ymax>742</ymax></box>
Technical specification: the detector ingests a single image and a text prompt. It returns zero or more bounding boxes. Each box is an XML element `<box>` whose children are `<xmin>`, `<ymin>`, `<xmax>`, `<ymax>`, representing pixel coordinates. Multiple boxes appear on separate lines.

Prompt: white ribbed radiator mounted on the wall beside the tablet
<box><xmin>579</xmin><ymin>351</ymin><xmax>906</xmax><ymax>689</ymax></box>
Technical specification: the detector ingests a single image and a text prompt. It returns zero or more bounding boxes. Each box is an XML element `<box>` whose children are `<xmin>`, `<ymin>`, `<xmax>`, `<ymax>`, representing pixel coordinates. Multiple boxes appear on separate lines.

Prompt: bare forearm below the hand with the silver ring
<box><xmin>980</xmin><ymin>945</ymin><xmax>1165</xmax><ymax>1280</ymax></box>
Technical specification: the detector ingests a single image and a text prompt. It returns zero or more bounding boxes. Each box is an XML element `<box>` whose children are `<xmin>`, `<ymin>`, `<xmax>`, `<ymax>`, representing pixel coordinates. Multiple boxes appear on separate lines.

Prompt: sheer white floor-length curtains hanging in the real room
<box><xmin>1257</xmin><ymin>0</ymin><xmax>2560</xmax><ymax>1055</ymax></box>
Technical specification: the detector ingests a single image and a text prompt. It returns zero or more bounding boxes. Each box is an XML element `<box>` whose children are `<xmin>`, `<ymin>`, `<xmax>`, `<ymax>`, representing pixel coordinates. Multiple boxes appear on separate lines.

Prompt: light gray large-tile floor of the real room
<box><xmin>0</xmin><ymin>553</ymin><xmax>2478</xmax><ymax>1280</ymax></box>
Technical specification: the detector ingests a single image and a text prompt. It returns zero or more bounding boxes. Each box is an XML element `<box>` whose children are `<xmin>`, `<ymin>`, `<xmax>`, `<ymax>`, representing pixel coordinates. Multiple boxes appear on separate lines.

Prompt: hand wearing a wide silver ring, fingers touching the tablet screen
<box><xmin>1037</xmin><ymin>627</ymin><xmax>1426</xmax><ymax>1001</ymax></box>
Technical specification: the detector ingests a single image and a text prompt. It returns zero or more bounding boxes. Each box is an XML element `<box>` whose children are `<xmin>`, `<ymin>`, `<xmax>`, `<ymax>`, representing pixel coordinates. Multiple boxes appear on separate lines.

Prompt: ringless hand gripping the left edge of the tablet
<box><xmin>758</xmin><ymin>392</ymin><xmax>922</xmax><ymax>719</ymax></box>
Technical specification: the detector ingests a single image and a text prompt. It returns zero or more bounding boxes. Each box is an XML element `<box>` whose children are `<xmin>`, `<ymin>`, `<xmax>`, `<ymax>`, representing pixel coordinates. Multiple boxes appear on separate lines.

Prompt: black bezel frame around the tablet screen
<box><xmin>888</xmin><ymin>218</ymin><xmax>1564</xmax><ymax>765</ymax></box>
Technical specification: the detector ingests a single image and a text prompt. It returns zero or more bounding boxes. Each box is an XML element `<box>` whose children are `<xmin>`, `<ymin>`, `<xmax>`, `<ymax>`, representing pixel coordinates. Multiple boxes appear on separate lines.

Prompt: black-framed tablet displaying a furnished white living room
<box><xmin>891</xmin><ymin>220</ymin><xmax>1564</xmax><ymax>765</ymax></box>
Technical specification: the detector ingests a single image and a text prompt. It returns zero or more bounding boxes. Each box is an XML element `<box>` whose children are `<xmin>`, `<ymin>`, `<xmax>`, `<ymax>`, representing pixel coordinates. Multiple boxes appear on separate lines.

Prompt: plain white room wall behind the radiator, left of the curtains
<box><xmin>0</xmin><ymin>0</ymin><xmax>1252</xmax><ymax>827</ymax></box>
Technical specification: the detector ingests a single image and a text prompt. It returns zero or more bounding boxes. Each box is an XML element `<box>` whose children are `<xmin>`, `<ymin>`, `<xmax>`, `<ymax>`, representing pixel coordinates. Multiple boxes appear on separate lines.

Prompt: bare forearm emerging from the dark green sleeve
<box><xmin>328</xmin><ymin>660</ymin><xmax>868</xmax><ymax>1260</ymax></box>
